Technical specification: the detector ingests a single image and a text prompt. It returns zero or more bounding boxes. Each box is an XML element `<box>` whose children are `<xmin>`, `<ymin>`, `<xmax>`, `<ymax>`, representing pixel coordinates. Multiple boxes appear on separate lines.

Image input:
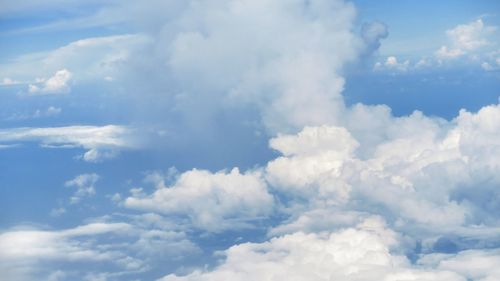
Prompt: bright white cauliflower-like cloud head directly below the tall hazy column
<box><xmin>266</xmin><ymin>126</ymin><xmax>358</xmax><ymax>201</ymax></box>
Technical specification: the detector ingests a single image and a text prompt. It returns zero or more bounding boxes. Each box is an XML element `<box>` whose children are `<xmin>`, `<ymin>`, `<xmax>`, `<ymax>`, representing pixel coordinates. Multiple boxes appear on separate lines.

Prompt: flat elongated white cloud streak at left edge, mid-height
<box><xmin>0</xmin><ymin>125</ymin><xmax>138</xmax><ymax>162</ymax></box>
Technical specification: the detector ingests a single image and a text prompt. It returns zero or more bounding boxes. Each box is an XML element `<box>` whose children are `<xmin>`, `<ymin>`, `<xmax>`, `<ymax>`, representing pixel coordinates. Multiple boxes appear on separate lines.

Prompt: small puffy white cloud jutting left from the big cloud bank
<box><xmin>124</xmin><ymin>168</ymin><xmax>273</xmax><ymax>232</ymax></box>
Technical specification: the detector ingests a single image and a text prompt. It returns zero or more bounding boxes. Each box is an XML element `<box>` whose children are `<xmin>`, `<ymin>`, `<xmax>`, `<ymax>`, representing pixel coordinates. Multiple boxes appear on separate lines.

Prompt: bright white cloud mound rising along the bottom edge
<box><xmin>161</xmin><ymin>219</ymin><xmax>466</xmax><ymax>281</ymax></box>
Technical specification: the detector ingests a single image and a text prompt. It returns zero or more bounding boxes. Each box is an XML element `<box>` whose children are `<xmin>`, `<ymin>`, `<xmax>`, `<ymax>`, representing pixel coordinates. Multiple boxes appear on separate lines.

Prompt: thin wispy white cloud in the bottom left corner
<box><xmin>0</xmin><ymin>223</ymin><xmax>140</xmax><ymax>280</ymax></box>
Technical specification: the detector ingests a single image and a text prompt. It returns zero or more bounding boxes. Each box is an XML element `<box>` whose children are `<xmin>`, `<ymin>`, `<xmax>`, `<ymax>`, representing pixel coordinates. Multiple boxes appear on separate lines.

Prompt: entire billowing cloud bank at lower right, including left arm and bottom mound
<box><xmin>114</xmin><ymin>101</ymin><xmax>500</xmax><ymax>281</ymax></box>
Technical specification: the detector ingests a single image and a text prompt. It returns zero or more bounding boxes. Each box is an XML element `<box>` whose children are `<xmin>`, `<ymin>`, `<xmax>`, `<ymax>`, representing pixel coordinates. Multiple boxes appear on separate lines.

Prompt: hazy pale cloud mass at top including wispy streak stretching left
<box><xmin>0</xmin><ymin>0</ymin><xmax>387</xmax><ymax>138</ymax></box>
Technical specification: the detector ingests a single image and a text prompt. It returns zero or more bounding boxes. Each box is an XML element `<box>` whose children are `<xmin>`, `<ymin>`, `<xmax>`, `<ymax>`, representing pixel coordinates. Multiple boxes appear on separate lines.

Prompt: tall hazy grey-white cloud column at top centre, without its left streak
<box><xmin>158</xmin><ymin>0</ymin><xmax>366</xmax><ymax>132</ymax></box>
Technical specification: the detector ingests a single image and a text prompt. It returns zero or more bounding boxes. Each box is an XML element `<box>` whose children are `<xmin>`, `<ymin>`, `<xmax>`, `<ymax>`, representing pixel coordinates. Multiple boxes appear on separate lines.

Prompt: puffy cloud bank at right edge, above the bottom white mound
<box><xmin>266</xmin><ymin>102</ymin><xmax>500</xmax><ymax>238</ymax></box>
